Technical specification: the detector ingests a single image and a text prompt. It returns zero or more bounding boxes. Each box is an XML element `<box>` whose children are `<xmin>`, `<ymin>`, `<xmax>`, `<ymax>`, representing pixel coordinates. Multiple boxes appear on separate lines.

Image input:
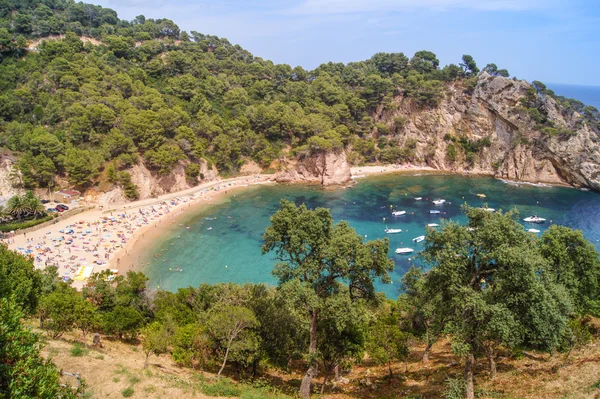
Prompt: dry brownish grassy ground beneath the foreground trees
<box><xmin>36</xmin><ymin>328</ymin><xmax>600</xmax><ymax>399</ymax></box>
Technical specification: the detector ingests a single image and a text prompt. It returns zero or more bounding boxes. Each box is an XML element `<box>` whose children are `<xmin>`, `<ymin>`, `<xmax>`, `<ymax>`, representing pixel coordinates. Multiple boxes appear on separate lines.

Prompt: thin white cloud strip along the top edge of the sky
<box><xmin>290</xmin><ymin>0</ymin><xmax>553</xmax><ymax>14</ymax></box>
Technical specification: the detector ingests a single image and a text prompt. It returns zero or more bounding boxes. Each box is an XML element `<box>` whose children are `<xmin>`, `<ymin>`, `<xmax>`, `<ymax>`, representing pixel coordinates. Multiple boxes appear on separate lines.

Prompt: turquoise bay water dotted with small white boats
<box><xmin>144</xmin><ymin>174</ymin><xmax>600</xmax><ymax>298</ymax></box>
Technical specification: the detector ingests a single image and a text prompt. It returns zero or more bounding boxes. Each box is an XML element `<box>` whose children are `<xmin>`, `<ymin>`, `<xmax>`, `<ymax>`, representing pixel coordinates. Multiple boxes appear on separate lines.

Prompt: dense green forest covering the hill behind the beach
<box><xmin>0</xmin><ymin>0</ymin><xmax>598</xmax><ymax>198</ymax></box>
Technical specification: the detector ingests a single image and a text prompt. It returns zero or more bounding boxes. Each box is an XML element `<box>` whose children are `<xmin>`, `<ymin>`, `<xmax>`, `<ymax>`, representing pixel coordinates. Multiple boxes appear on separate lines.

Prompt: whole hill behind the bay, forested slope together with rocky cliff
<box><xmin>0</xmin><ymin>1</ymin><xmax>600</xmax><ymax>198</ymax></box>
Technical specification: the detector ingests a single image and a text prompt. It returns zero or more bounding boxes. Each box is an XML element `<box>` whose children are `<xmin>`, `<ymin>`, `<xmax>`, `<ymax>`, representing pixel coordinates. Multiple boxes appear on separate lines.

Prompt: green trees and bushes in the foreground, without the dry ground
<box><xmin>0</xmin><ymin>201</ymin><xmax>600</xmax><ymax>397</ymax></box>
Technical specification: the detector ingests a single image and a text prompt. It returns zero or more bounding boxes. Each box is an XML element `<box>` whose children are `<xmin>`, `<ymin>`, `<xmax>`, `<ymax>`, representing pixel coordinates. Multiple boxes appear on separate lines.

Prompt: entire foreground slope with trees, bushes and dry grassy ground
<box><xmin>0</xmin><ymin>205</ymin><xmax>600</xmax><ymax>399</ymax></box>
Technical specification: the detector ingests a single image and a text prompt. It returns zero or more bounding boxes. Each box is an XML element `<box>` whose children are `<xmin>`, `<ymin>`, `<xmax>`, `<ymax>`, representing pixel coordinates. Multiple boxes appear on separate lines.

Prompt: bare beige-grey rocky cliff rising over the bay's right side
<box><xmin>374</xmin><ymin>73</ymin><xmax>600</xmax><ymax>190</ymax></box>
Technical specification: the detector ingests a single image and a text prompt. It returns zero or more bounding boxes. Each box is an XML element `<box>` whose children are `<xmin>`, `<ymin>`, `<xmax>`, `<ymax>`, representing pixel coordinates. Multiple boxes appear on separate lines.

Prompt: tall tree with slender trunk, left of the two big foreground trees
<box><xmin>262</xmin><ymin>200</ymin><xmax>394</xmax><ymax>397</ymax></box>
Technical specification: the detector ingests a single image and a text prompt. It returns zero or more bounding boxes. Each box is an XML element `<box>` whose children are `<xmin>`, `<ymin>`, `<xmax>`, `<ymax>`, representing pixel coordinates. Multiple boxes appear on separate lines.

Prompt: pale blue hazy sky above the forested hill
<box><xmin>92</xmin><ymin>0</ymin><xmax>600</xmax><ymax>86</ymax></box>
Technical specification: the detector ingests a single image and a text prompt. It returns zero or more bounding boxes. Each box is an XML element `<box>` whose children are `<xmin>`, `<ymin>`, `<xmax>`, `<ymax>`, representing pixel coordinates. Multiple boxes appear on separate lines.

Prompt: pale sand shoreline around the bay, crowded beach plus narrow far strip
<box><xmin>8</xmin><ymin>164</ymin><xmax>576</xmax><ymax>288</ymax></box>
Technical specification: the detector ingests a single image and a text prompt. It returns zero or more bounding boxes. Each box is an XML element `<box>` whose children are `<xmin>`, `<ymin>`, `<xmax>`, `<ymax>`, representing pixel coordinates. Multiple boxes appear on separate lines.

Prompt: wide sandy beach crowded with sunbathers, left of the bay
<box><xmin>5</xmin><ymin>175</ymin><xmax>272</xmax><ymax>288</ymax></box>
